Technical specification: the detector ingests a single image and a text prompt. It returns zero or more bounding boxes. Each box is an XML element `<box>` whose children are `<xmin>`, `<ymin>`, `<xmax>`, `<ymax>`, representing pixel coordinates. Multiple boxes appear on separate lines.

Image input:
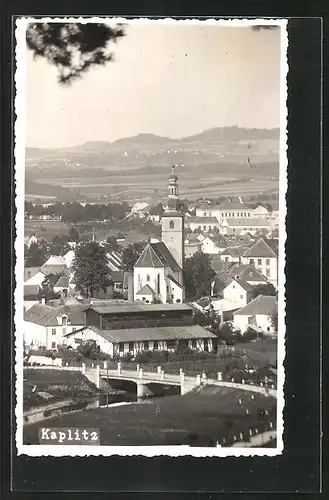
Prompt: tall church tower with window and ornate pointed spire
<box><xmin>162</xmin><ymin>166</ymin><xmax>184</xmax><ymax>272</ymax></box>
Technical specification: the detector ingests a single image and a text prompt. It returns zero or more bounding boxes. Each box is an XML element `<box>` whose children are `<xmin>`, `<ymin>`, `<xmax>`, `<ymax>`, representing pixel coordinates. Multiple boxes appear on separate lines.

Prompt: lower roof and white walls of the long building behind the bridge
<box><xmin>65</xmin><ymin>325</ymin><xmax>217</xmax><ymax>357</ymax></box>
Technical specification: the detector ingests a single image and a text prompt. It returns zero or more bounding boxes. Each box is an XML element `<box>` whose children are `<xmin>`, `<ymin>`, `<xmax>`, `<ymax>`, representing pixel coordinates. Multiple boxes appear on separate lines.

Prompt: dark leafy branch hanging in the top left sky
<box><xmin>26</xmin><ymin>23</ymin><xmax>125</xmax><ymax>84</ymax></box>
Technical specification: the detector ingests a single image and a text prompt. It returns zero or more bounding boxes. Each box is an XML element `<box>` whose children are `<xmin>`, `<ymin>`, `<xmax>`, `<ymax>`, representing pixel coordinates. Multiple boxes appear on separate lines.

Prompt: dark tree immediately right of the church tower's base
<box><xmin>184</xmin><ymin>252</ymin><xmax>216</xmax><ymax>298</ymax></box>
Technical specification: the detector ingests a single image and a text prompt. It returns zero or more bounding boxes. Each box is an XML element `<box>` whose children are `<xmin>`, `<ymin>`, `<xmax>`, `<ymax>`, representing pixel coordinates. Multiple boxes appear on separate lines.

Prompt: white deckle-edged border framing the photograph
<box><xmin>14</xmin><ymin>16</ymin><xmax>288</xmax><ymax>457</ymax></box>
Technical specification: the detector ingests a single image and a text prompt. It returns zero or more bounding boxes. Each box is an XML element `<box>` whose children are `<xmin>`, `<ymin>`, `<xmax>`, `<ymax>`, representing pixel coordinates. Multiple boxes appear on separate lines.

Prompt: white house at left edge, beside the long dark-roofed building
<box><xmin>23</xmin><ymin>304</ymin><xmax>85</xmax><ymax>350</ymax></box>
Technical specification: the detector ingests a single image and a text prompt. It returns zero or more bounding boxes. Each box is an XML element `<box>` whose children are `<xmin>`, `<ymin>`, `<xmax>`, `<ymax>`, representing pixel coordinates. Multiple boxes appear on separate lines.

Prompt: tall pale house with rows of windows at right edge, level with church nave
<box><xmin>241</xmin><ymin>238</ymin><xmax>278</xmax><ymax>288</ymax></box>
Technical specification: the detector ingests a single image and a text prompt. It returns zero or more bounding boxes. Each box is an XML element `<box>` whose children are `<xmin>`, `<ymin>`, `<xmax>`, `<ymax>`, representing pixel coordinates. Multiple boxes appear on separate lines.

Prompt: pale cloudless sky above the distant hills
<box><xmin>26</xmin><ymin>23</ymin><xmax>280</xmax><ymax>147</ymax></box>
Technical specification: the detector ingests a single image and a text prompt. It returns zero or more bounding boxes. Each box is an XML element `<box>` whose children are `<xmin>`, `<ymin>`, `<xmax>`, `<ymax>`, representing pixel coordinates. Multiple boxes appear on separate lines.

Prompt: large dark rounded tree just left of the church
<box><xmin>73</xmin><ymin>241</ymin><xmax>111</xmax><ymax>297</ymax></box>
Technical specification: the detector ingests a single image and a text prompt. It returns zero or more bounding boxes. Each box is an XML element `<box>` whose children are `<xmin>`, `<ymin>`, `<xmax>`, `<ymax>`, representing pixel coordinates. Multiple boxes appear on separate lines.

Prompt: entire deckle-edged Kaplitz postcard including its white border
<box><xmin>14</xmin><ymin>17</ymin><xmax>288</xmax><ymax>457</ymax></box>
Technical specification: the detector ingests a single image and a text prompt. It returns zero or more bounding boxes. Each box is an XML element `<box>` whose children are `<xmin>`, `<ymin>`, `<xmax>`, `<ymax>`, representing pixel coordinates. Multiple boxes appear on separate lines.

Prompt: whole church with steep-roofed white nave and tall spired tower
<box><xmin>134</xmin><ymin>167</ymin><xmax>185</xmax><ymax>304</ymax></box>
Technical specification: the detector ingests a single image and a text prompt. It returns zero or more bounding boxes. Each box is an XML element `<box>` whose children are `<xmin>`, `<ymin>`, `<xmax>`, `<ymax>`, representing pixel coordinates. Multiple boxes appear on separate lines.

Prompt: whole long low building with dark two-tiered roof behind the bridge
<box><xmin>65</xmin><ymin>303</ymin><xmax>217</xmax><ymax>357</ymax></box>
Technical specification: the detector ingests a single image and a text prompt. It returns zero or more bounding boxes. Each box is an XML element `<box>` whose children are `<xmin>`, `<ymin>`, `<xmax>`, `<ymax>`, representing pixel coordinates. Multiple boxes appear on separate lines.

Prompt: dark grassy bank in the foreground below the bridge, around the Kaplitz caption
<box><xmin>24</xmin><ymin>386</ymin><xmax>276</xmax><ymax>446</ymax></box>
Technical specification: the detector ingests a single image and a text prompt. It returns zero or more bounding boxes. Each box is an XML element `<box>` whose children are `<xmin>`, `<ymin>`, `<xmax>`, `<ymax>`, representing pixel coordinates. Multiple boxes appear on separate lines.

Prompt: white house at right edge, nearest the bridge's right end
<box><xmin>233</xmin><ymin>295</ymin><xmax>278</xmax><ymax>332</ymax></box>
